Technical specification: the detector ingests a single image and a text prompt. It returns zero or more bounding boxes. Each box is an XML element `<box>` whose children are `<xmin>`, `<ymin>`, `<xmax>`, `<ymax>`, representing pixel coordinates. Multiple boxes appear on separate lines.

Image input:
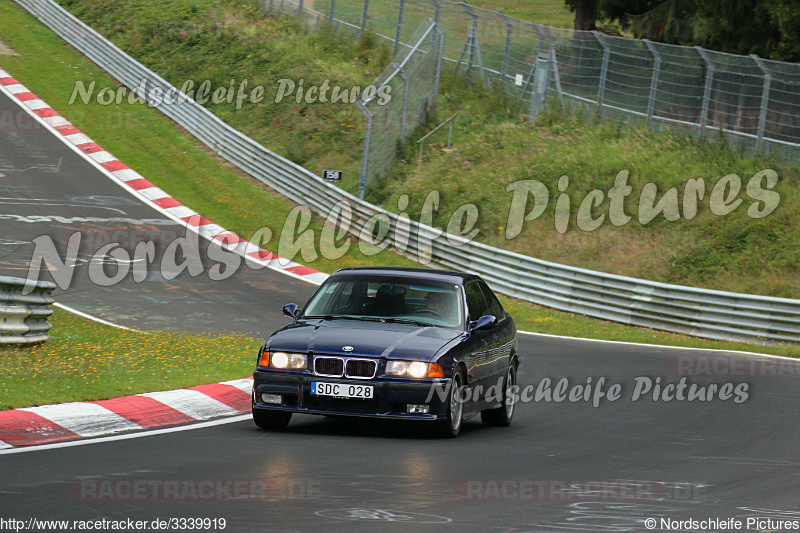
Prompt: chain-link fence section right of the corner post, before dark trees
<box><xmin>551</xmin><ymin>28</ymin><xmax>800</xmax><ymax>162</ymax></box>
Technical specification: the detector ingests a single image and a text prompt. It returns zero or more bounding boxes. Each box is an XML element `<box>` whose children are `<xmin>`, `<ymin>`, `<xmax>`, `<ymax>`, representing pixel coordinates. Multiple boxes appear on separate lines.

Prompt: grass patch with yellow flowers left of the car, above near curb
<box><xmin>0</xmin><ymin>310</ymin><xmax>262</xmax><ymax>409</ymax></box>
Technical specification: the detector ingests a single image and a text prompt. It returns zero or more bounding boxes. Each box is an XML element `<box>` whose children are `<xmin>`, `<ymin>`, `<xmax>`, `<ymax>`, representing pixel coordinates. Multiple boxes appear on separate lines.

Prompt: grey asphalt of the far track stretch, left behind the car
<box><xmin>0</xmin><ymin>89</ymin><xmax>314</xmax><ymax>335</ymax></box>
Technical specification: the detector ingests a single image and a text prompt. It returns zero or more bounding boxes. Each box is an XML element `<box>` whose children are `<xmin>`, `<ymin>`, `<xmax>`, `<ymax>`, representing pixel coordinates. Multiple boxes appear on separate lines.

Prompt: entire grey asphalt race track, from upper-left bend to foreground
<box><xmin>0</xmin><ymin>85</ymin><xmax>800</xmax><ymax>532</ymax></box>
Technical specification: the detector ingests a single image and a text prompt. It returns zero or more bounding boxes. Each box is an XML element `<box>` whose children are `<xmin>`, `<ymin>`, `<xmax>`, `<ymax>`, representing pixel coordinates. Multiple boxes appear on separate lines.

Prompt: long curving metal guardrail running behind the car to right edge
<box><xmin>18</xmin><ymin>0</ymin><xmax>800</xmax><ymax>344</ymax></box>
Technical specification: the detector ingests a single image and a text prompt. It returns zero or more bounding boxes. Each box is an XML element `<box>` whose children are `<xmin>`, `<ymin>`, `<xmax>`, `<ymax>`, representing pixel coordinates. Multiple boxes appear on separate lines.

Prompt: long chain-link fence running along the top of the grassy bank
<box><xmin>261</xmin><ymin>0</ymin><xmax>800</xmax><ymax>183</ymax></box>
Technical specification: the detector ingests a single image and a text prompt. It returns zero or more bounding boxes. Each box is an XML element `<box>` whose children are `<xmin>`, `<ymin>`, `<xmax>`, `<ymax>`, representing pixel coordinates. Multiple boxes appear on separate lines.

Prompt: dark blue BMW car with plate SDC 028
<box><xmin>253</xmin><ymin>267</ymin><xmax>519</xmax><ymax>437</ymax></box>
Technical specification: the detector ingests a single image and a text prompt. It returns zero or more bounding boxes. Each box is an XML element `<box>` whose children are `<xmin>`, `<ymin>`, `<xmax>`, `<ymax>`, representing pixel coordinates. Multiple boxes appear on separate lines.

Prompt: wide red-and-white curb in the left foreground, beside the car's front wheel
<box><xmin>0</xmin><ymin>378</ymin><xmax>253</xmax><ymax>450</ymax></box>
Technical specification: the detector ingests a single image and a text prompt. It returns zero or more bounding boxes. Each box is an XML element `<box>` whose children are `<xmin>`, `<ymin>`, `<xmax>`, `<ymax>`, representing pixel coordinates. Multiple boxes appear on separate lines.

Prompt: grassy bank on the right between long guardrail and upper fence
<box><xmin>376</xmin><ymin>98</ymin><xmax>800</xmax><ymax>298</ymax></box>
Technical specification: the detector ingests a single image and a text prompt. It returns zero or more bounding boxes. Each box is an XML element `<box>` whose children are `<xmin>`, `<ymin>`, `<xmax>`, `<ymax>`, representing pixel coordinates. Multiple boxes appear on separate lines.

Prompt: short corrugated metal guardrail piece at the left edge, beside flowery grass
<box><xmin>0</xmin><ymin>276</ymin><xmax>56</xmax><ymax>345</ymax></box>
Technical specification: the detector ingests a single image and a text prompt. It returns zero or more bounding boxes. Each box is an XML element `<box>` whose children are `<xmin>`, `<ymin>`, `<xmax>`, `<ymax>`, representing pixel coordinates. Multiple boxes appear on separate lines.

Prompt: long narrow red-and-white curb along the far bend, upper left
<box><xmin>0</xmin><ymin>69</ymin><xmax>328</xmax><ymax>285</ymax></box>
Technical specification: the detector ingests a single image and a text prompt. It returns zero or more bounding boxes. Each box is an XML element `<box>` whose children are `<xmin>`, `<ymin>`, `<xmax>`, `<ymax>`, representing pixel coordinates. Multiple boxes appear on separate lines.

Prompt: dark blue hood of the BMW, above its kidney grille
<box><xmin>267</xmin><ymin>319</ymin><xmax>462</xmax><ymax>361</ymax></box>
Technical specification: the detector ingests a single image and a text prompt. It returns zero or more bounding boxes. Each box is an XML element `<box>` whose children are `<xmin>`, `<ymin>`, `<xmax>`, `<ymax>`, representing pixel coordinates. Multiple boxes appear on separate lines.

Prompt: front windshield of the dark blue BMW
<box><xmin>303</xmin><ymin>276</ymin><xmax>464</xmax><ymax>328</ymax></box>
